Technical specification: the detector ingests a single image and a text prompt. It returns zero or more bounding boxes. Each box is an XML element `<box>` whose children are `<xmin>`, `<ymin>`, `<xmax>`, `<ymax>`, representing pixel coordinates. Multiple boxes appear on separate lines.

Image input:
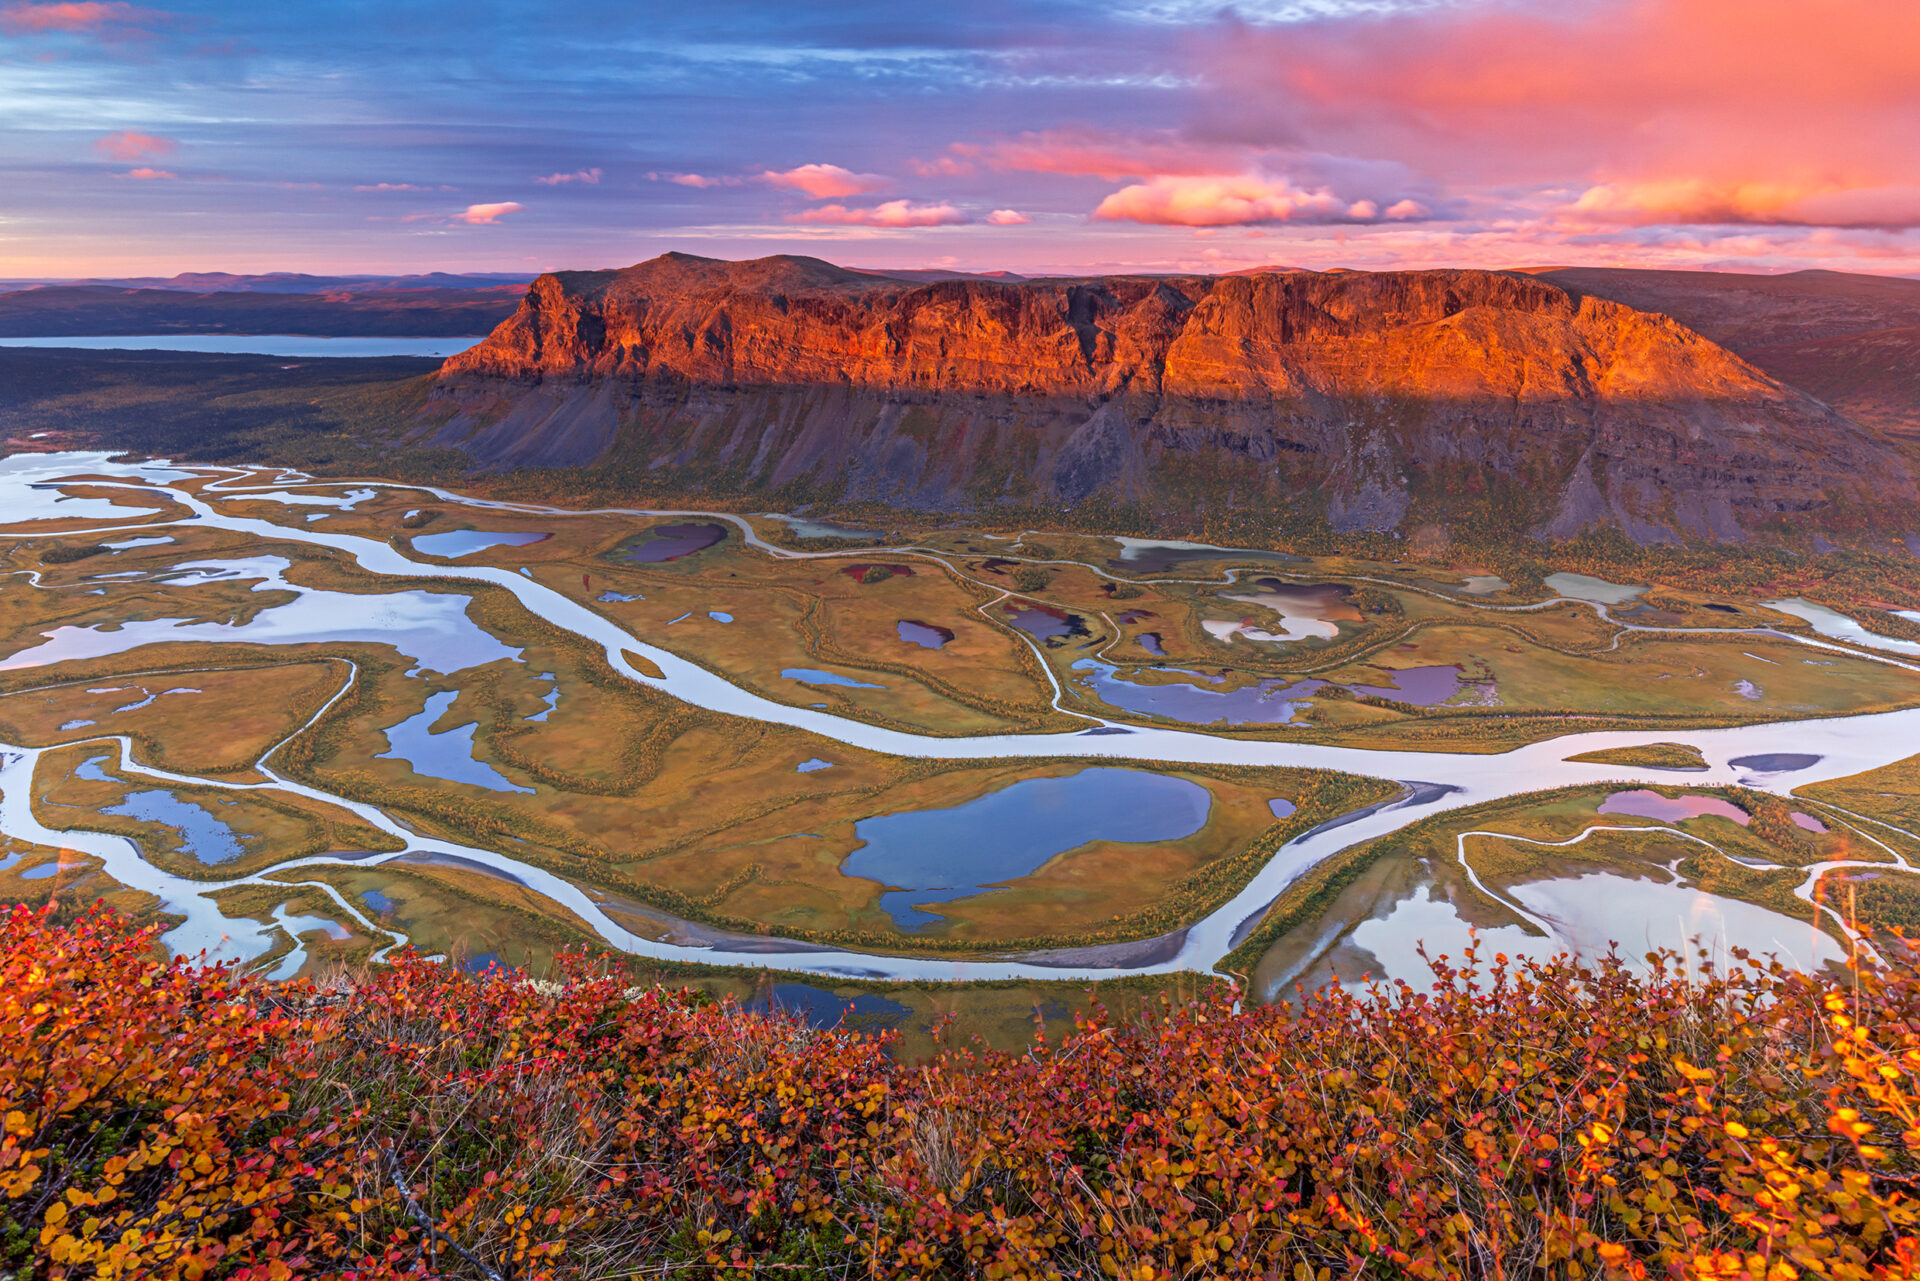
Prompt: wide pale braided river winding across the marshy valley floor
<box><xmin>11</xmin><ymin>453</ymin><xmax>1920</xmax><ymax>979</ymax></box>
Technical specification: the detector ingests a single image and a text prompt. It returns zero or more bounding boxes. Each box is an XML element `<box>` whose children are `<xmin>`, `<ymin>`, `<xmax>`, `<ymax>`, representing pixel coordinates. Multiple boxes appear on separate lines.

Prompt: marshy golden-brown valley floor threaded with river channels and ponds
<box><xmin>0</xmin><ymin>455</ymin><xmax>1920</xmax><ymax>1052</ymax></box>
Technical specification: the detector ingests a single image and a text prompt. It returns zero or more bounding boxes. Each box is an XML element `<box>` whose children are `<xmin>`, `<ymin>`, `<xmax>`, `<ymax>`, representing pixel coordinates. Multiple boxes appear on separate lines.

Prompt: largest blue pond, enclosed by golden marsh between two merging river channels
<box><xmin>841</xmin><ymin>768</ymin><xmax>1213</xmax><ymax>930</ymax></box>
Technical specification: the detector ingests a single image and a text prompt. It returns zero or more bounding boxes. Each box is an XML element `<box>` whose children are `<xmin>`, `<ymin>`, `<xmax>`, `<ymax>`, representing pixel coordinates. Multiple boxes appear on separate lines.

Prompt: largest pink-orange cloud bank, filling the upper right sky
<box><xmin>1205</xmin><ymin>0</ymin><xmax>1920</xmax><ymax>227</ymax></box>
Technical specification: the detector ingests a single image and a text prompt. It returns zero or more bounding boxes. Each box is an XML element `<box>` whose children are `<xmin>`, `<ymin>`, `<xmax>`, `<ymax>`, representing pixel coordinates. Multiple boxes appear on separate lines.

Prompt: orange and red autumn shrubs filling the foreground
<box><xmin>0</xmin><ymin>908</ymin><xmax>1920</xmax><ymax>1281</ymax></box>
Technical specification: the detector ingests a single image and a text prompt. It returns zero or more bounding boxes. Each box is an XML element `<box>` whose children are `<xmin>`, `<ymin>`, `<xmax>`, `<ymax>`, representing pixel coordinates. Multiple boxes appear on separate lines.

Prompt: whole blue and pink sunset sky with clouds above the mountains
<box><xmin>0</xmin><ymin>0</ymin><xmax>1920</xmax><ymax>277</ymax></box>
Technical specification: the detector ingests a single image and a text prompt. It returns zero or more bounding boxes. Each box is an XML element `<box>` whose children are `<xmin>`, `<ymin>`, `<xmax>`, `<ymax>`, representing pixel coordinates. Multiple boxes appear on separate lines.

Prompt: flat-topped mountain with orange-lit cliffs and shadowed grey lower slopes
<box><xmin>436</xmin><ymin>254</ymin><xmax>1920</xmax><ymax>540</ymax></box>
